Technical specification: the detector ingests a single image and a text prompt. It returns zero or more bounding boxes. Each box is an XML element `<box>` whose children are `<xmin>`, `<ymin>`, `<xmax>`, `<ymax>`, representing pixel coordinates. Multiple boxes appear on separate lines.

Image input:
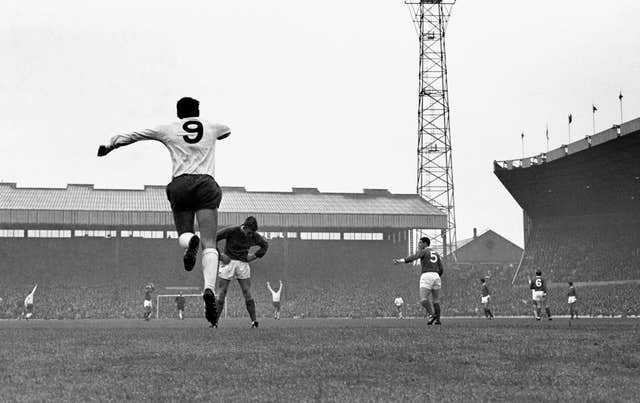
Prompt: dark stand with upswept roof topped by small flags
<box><xmin>494</xmin><ymin>119</ymin><xmax>640</xmax><ymax>315</ymax></box>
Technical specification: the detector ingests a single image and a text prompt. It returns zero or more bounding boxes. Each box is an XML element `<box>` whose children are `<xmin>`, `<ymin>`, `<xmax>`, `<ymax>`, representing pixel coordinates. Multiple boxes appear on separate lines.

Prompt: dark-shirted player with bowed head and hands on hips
<box><xmin>211</xmin><ymin>216</ymin><xmax>269</xmax><ymax>327</ymax></box>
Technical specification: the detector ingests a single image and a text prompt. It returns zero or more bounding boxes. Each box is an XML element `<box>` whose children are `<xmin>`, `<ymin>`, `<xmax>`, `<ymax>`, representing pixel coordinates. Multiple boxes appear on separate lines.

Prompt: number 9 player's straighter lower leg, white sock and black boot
<box><xmin>196</xmin><ymin>209</ymin><xmax>219</xmax><ymax>326</ymax></box>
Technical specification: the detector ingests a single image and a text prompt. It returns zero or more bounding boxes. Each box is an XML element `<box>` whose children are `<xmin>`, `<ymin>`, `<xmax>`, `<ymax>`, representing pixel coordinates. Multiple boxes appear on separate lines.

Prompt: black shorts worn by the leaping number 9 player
<box><xmin>167</xmin><ymin>174</ymin><xmax>222</xmax><ymax>211</ymax></box>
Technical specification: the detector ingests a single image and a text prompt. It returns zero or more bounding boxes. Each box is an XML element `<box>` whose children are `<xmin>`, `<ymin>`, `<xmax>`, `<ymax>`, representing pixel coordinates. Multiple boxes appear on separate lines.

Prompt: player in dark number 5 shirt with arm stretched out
<box><xmin>393</xmin><ymin>236</ymin><xmax>444</xmax><ymax>325</ymax></box>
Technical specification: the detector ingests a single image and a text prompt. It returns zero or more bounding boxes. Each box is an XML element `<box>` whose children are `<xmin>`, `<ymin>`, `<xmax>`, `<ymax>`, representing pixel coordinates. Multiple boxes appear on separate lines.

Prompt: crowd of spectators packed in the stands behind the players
<box><xmin>0</xmin><ymin>222</ymin><xmax>640</xmax><ymax>319</ymax></box>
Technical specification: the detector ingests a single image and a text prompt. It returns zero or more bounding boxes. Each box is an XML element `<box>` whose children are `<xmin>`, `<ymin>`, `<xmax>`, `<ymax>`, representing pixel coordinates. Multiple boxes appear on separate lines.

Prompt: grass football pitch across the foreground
<box><xmin>0</xmin><ymin>318</ymin><xmax>640</xmax><ymax>402</ymax></box>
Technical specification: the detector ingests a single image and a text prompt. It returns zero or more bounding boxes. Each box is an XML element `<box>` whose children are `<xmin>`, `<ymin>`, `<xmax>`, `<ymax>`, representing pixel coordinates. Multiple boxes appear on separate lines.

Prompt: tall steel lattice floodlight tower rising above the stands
<box><xmin>405</xmin><ymin>0</ymin><xmax>456</xmax><ymax>255</ymax></box>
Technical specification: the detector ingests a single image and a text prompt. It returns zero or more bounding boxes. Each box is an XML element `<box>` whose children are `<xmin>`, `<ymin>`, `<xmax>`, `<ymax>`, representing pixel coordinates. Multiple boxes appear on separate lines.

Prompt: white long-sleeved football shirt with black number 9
<box><xmin>109</xmin><ymin>118</ymin><xmax>231</xmax><ymax>178</ymax></box>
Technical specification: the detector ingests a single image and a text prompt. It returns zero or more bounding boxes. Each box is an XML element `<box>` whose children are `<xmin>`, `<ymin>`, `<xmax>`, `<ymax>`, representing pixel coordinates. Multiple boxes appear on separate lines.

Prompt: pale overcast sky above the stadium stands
<box><xmin>0</xmin><ymin>0</ymin><xmax>640</xmax><ymax>245</ymax></box>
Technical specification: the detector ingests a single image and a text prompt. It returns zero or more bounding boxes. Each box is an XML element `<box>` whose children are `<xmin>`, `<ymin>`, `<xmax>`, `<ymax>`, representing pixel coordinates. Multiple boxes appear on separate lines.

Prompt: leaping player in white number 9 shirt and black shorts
<box><xmin>98</xmin><ymin>98</ymin><xmax>231</xmax><ymax>324</ymax></box>
